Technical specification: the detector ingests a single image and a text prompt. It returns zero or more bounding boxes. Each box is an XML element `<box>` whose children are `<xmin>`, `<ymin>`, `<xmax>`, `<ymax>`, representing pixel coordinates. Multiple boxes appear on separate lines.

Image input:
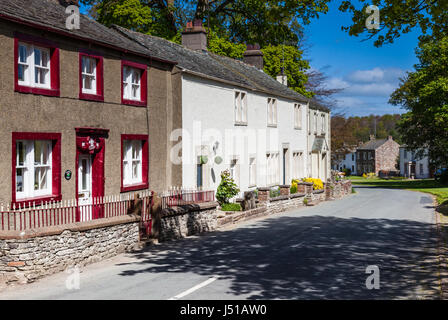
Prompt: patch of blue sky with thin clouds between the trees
<box><xmin>306</xmin><ymin>1</ymin><xmax>420</xmax><ymax>116</ymax></box>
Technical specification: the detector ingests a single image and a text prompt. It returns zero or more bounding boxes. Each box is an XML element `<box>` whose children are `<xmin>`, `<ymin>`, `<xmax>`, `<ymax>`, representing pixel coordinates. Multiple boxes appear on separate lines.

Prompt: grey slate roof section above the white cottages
<box><xmin>112</xmin><ymin>25</ymin><xmax>328</xmax><ymax>111</ymax></box>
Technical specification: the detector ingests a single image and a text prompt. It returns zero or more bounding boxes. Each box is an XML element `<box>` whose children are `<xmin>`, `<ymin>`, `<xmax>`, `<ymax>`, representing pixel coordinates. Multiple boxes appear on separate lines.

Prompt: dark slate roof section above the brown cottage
<box><xmin>0</xmin><ymin>0</ymin><xmax>173</xmax><ymax>60</ymax></box>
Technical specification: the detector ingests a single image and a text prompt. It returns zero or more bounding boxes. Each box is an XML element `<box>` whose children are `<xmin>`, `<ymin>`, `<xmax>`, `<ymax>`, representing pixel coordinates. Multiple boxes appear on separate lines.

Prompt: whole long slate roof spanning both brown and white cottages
<box><xmin>0</xmin><ymin>0</ymin><xmax>329</xmax><ymax>112</ymax></box>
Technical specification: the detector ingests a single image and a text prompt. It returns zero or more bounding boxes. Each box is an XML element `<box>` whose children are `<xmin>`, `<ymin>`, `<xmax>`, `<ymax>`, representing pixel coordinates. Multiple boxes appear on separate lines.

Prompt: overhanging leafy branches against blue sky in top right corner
<box><xmin>339</xmin><ymin>0</ymin><xmax>448</xmax><ymax>47</ymax></box>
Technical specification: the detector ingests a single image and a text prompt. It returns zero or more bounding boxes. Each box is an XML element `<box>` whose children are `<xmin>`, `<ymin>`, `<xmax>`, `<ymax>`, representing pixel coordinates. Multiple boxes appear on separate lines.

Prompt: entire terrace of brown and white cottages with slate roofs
<box><xmin>0</xmin><ymin>0</ymin><xmax>330</xmax><ymax>205</ymax></box>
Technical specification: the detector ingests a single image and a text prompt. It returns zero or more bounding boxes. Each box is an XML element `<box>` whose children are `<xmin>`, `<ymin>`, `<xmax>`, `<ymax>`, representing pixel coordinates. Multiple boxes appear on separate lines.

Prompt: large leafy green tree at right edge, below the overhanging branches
<box><xmin>389</xmin><ymin>37</ymin><xmax>448</xmax><ymax>166</ymax></box>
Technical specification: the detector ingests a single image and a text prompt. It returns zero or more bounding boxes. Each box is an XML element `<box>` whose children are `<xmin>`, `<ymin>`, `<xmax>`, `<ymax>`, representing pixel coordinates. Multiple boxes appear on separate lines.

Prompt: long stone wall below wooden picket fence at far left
<box><xmin>0</xmin><ymin>216</ymin><xmax>140</xmax><ymax>287</ymax></box>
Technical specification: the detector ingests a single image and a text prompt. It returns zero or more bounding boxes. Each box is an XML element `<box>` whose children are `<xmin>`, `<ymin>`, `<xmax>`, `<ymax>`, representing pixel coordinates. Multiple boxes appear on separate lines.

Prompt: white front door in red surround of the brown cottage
<box><xmin>78</xmin><ymin>154</ymin><xmax>92</xmax><ymax>221</ymax></box>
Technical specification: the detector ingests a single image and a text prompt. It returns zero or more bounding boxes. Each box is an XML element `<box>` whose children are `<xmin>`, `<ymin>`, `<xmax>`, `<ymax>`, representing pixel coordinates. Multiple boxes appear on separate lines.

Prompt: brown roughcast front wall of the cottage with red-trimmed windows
<box><xmin>0</xmin><ymin>21</ymin><xmax>174</xmax><ymax>202</ymax></box>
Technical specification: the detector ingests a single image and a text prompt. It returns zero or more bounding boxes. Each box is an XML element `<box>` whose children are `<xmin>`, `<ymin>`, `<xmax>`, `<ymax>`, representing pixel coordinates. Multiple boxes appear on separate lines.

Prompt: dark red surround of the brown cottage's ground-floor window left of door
<box><xmin>11</xmin><ymin>132</ymin><xmax>62</xmax><ymax>206</ymax></box>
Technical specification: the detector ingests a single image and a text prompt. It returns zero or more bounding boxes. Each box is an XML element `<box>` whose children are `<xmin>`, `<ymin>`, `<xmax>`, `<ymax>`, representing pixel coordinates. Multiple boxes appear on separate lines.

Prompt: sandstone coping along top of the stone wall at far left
<box><xmin>0</xmin><ymin>215</ymin><xmax>140</xmax><ymax>240</ymax></box>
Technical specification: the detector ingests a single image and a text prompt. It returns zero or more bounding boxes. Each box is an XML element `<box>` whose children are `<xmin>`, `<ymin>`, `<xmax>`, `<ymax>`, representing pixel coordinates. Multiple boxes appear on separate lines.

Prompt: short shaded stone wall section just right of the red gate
<box><xmin>158</xmin><ymin>202</ymin><xmax>218</xmax><ymax>241</ymax></box>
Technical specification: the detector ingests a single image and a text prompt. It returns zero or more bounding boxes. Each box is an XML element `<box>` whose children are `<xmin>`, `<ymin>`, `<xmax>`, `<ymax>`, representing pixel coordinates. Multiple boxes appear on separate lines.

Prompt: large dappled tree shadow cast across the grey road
<box><xmin>117</xmin><ymin>215</ymin><xmax>440</xmax><ymax>299</ymax></box>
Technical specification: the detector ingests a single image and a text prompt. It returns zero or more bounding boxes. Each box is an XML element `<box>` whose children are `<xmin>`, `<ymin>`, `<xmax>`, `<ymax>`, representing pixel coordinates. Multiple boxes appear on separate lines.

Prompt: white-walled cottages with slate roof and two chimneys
<box><xmin>114</xmin><ymin>21</ymin><xmax>330</xmax><ymax>191</ymax></box>
